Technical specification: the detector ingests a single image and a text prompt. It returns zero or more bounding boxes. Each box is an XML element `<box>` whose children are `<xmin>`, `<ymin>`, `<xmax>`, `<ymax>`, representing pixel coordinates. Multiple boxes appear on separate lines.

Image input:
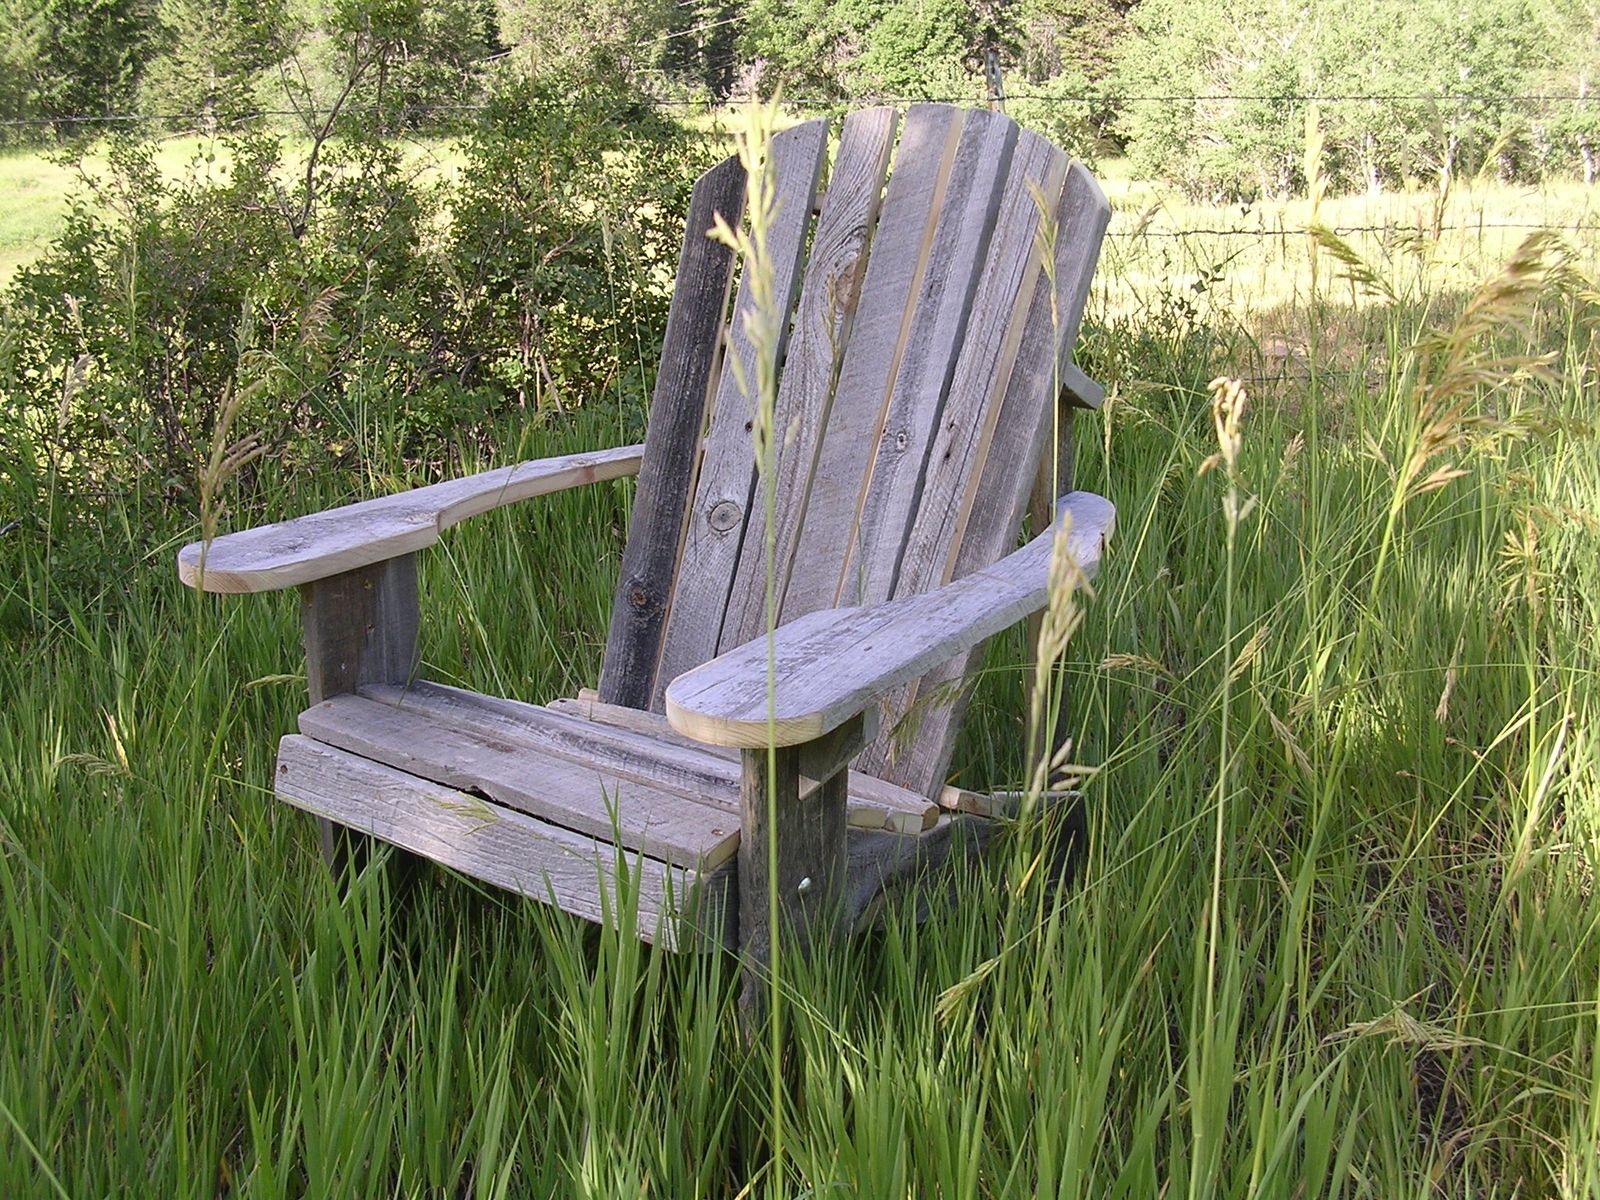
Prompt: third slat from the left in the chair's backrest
<box><xmin>718</xmin><ymin>109</ymin><xmax>899</xmax><ymax>648</ymax></box>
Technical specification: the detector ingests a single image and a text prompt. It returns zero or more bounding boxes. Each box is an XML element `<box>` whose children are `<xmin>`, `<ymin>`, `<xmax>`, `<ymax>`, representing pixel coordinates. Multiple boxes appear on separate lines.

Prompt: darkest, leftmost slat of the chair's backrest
<box><xmin>600</xmin><ymin>158</ymin><xmax>744</xmax><ymax>709</ymax></box>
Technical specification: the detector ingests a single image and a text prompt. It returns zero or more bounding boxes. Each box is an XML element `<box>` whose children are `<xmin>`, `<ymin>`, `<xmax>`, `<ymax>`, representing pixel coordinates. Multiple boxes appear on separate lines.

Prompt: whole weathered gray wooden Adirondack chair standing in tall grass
<box><xmin>179</xmin><ymin>104</ymin><xmax>1114</xmax><ymax>979</ymax></box>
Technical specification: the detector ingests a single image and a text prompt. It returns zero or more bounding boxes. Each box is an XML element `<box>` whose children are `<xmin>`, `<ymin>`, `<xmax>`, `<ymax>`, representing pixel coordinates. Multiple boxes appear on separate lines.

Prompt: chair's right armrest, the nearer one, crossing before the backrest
<box><xmin>667</xmin><ymin>491</ymin><xmax>1117</xmax><ymax>749</ymax></box>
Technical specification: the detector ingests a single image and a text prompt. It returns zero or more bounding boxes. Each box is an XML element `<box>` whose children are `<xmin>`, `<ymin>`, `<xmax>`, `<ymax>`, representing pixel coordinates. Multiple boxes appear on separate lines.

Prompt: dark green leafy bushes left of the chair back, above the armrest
<box><xmin>0</xmin><ymin>70</ymin><xmax>702</xmax><ymax>550</ymax></box>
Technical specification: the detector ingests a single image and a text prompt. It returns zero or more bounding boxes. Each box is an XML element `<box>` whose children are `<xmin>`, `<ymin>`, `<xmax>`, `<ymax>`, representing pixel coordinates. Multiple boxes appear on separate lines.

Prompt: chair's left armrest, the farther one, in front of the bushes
<box><xmin>178</xmin><ymin>446</ymin><xmax>643</xmax><ymax>592</ymax></box>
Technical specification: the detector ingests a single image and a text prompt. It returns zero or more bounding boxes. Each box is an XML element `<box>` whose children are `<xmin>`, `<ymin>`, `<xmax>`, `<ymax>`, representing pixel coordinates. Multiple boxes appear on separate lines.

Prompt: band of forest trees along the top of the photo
<box><xmin>9</xmin><ymin>0</ymin><xmax>1600</xmax><ymax>198</ymax></box>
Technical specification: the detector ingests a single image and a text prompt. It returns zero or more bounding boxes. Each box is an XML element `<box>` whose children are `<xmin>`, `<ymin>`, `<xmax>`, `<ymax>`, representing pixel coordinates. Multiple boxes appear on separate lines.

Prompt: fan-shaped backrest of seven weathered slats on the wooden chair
<box><xmin>600</xmin><ymin>104</ymin><xmax>1110</xmax><ymax>795</ymax></box>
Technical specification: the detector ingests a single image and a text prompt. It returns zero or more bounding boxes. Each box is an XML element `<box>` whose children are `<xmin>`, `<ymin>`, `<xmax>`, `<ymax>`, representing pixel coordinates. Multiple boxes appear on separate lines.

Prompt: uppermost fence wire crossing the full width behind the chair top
<box><xmin>9</xmin><ymin>91</ymin><xmax>1600</xmax><ymax>128</ymax></box>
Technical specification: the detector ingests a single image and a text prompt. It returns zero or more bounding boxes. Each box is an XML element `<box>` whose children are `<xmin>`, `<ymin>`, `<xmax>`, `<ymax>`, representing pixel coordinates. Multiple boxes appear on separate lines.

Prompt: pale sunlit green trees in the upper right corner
<box><xmin>1115</xmin><ymin>0</ymin><xmax>1594</xmax><ymax>198</ymax></box>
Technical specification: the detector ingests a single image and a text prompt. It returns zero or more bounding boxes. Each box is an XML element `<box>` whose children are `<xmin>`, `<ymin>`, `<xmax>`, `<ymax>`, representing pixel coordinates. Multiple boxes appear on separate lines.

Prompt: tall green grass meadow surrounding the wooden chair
<box><xmin>0</xmin><ymin>124</ymin><xmax>1600</xmax><ymax>1200</ymax></box>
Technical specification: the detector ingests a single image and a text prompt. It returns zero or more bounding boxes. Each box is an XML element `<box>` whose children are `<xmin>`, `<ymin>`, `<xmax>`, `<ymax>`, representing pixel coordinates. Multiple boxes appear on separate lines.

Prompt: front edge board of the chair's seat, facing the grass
<box><xmin>277</xmin><ymin>734</ymin><xmax>731</xmax><ymax>949</ymax></box>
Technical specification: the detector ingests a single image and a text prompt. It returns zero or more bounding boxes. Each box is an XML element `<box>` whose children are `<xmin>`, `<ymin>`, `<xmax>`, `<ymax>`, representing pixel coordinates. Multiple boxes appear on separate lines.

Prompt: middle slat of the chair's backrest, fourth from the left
<box><xmin>782</xmin><ymin>104</ymin><xmax>962</xmax><ymax>621</ymax></box>
